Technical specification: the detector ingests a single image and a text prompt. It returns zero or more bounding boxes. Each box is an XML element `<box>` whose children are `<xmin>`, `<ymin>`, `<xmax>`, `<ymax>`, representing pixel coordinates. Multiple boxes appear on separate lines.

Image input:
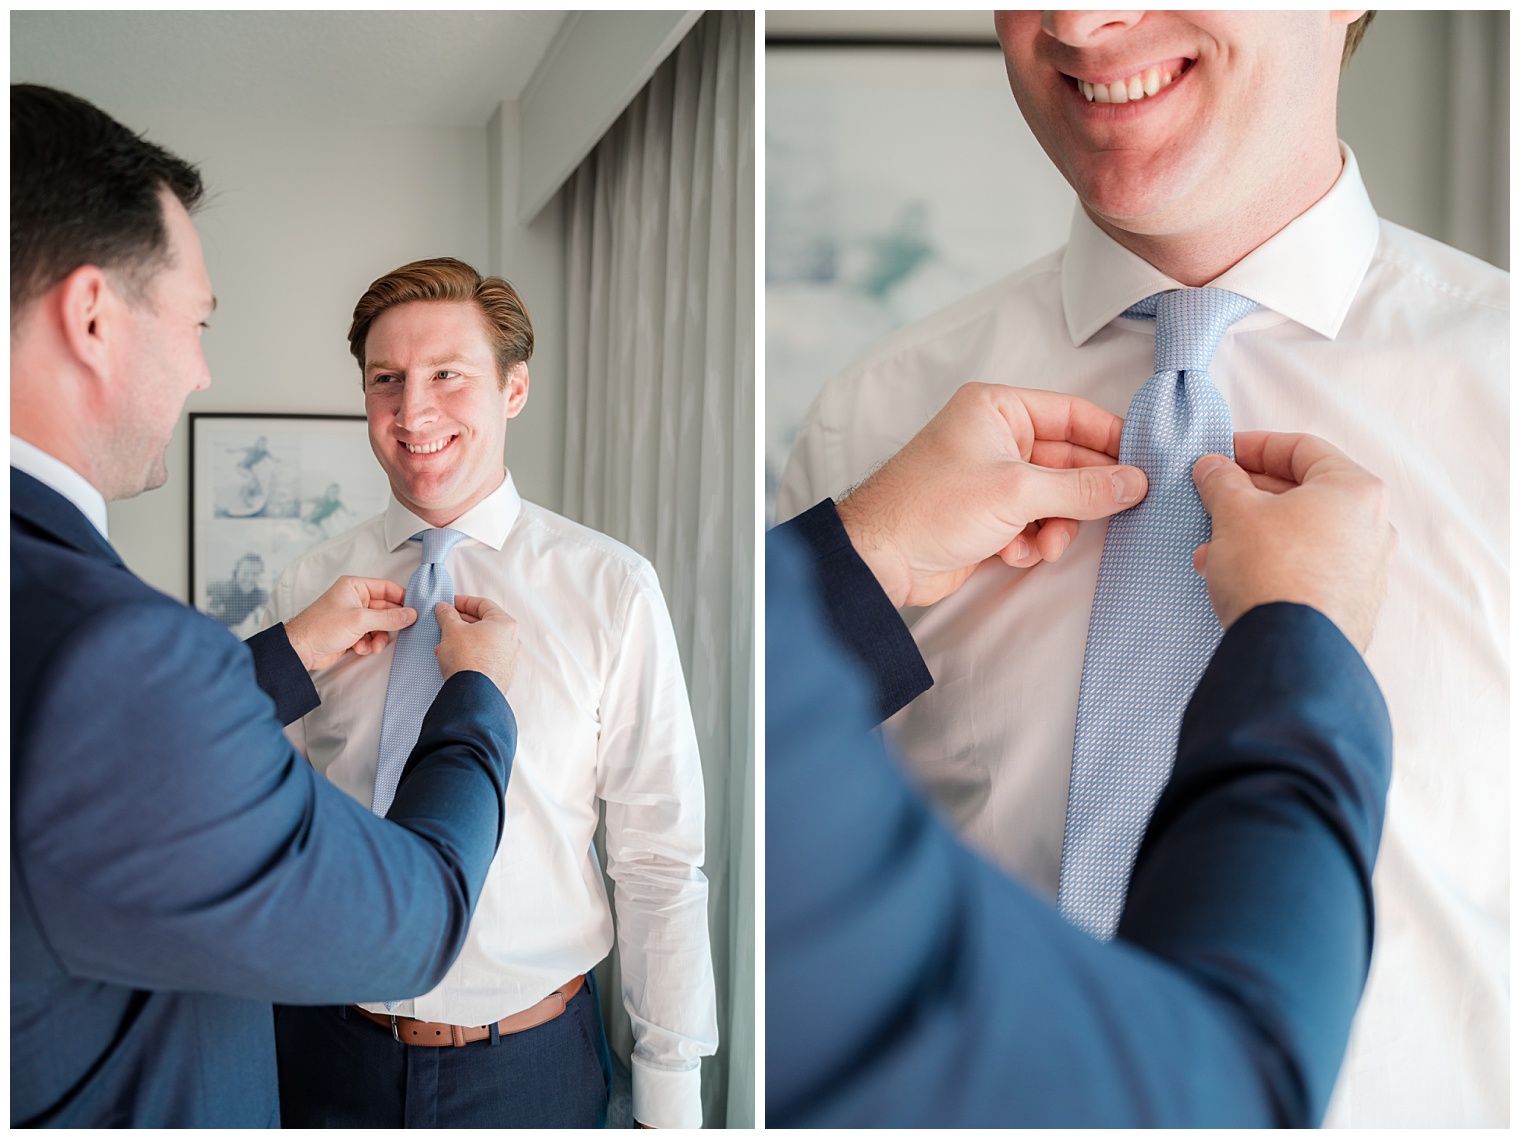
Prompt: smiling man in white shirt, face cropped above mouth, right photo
<box><xmin>778</xmin><ymin>11</ymin><xmax>1509</xmax><ymax>1127</ymax></box>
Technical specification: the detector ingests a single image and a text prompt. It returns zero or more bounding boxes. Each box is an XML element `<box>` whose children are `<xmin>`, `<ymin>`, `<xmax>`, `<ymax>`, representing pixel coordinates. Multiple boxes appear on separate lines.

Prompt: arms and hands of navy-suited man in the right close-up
<box><xmin>766</xmin><ymin>385</ymin><xmax>1395</xmax><ymax>1127</ymax></box>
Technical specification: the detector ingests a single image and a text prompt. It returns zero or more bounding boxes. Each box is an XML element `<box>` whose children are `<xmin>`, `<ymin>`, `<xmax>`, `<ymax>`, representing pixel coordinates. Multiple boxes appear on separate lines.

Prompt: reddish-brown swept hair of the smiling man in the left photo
<box><xmin>348</xmin><ymin>257</ymin><xmax>534</xmax><ymax>388</ymax></box>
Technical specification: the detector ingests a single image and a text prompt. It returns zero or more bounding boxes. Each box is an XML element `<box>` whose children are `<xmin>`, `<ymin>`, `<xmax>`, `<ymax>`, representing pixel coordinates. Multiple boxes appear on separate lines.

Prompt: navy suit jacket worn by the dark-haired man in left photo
<box><xmin>11</xmin><ymin>470</ymin><xmax>517</xmax><ymax>1127</ymax></box>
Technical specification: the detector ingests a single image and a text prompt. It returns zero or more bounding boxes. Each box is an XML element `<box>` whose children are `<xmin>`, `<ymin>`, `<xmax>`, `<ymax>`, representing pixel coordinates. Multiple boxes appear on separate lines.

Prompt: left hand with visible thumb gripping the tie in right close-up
<box><xmin>839</xmin><ymin>383</ymin><xmax>1146</xmax><ymax>605</ymax></box>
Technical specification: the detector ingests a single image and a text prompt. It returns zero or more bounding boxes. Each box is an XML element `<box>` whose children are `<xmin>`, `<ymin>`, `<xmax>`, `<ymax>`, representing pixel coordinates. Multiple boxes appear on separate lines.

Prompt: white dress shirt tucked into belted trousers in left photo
<box><xmin>266</xmin><ymin>474</ymin><xmax>717</xmax><ymax>1127</ymax></box>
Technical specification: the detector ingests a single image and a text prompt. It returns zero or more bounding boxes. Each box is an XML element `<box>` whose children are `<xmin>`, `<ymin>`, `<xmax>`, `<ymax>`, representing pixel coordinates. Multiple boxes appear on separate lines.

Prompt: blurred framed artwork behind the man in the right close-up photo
<box><xmin>765</xmin><ymin>43</ymin><xmax>1075</xmax><ymax>520</ymax></box>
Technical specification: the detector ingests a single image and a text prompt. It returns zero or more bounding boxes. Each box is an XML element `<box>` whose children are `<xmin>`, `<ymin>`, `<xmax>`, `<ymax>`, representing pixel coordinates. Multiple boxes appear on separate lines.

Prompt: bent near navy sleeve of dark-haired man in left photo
<box><xmin>12</xmin><ymin>602</ymin><xmax>517</xmax><ymax>1004</ymax></box>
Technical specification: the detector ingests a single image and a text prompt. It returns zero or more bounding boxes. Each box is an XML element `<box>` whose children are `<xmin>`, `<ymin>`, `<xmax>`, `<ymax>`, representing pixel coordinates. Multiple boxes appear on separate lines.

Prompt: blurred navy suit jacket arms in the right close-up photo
<box><xmin>766</xmin><ymin>503</ymin><xmax>1392</xmax><ymax>1127</ymax></box>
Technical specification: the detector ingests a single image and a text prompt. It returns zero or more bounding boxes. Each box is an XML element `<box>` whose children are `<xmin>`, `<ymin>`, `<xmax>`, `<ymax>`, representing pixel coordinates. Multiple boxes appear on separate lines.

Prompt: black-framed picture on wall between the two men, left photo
<box><xmin>190</xmin><ymin>412</ymin><xmax>389</xmax><ymax>637</ymax></box>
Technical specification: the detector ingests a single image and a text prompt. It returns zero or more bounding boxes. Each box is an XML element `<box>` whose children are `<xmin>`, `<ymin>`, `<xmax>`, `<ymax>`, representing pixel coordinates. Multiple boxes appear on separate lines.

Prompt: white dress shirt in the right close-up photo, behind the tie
<box><xmin>778</xmin><ymin>146</ymin><xmax>1509</xmax><ymax>1127</ymax></box>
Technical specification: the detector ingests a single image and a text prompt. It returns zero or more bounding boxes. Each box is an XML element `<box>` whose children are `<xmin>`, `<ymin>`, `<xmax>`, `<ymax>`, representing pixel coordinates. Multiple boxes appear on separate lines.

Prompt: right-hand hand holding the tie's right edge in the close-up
<box><xmin>1193</xmin><ymin>432</ymin><xmax>1398</xmax><ymax>652</ymax></box>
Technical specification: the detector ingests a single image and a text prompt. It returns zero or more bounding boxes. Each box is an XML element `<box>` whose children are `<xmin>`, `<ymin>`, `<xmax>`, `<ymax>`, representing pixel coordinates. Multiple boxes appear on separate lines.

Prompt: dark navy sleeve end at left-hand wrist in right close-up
<box><xmin>775</xmin><ymin>499</ymin><xmax>935</xmax><ymax>721</ymax></box>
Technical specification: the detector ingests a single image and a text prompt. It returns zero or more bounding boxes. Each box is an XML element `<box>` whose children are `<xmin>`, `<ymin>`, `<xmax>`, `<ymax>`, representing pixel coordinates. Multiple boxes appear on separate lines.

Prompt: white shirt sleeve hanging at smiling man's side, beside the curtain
<box><xmin>597</xmin><ymin>563</ymin><xmax>717</xmax><ymax>1127</ymax></box>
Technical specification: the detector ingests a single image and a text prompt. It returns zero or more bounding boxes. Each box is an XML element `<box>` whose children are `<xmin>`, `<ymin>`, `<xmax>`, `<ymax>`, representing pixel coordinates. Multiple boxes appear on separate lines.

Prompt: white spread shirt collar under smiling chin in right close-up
<box><xmin>1061</xmin><ymin>143</ymin><xmax>1379</xmax><ymax>344</ymax></box>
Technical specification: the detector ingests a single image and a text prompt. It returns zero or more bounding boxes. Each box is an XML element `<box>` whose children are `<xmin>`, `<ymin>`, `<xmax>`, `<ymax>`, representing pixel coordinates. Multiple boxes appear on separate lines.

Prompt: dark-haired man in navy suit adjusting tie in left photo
<box><xmin>11</xmin><ymin>87</ymin><xmax>517</xmax><ymax>1127</ymax></box>
